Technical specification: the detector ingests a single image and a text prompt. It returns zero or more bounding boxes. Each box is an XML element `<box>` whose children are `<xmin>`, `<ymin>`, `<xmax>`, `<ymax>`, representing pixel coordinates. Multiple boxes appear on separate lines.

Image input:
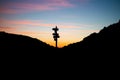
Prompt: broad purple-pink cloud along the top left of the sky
<box><xmin>0</xmin><ymin>0</ymin><xmax>73</xmax><ymax>14</ymax></box>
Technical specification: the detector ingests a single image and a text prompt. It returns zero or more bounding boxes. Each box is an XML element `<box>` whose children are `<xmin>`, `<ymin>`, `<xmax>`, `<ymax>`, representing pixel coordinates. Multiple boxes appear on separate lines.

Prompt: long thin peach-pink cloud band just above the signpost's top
<box><xmin>0</xmin><ymin>19</ymin><xmax>80</xmax><ymax>28</ymax></box>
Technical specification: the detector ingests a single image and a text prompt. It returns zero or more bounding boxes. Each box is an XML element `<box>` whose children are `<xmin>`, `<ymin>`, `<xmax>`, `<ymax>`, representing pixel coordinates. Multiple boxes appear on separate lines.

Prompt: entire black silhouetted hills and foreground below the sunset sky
<box><xmin>0</xmin><ymin>22</ymin><xmax>120</xmax><ymax>75</ymax></box>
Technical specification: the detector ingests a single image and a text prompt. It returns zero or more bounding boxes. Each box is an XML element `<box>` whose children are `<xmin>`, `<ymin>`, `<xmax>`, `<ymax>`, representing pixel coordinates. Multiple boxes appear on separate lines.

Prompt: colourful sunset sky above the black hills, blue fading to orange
<box><xmin>0</xmin><ymin>0</ymin><xmax>120</xmax><ymax>47</ymax></box>
